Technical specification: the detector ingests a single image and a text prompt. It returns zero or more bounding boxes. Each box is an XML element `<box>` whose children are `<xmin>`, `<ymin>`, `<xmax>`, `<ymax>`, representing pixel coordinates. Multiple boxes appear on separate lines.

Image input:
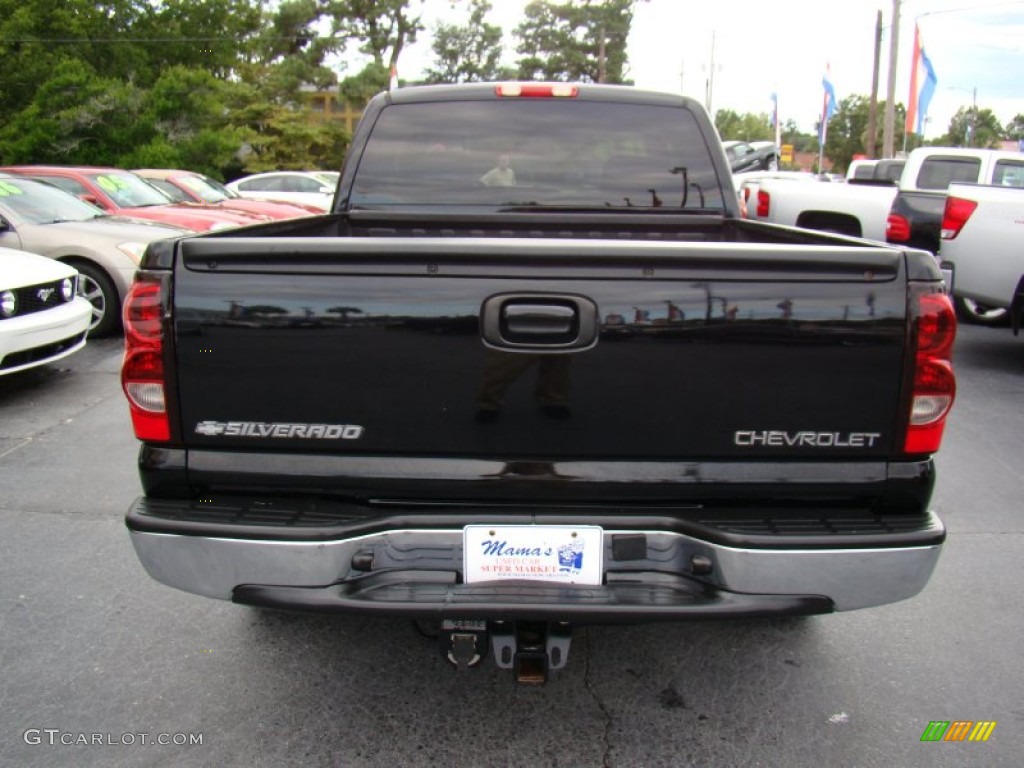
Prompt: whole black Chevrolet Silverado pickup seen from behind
<box><xmin>123</xmin><ymin>83</ymin><xmax>955</xmax><ymax>681</ymax></box>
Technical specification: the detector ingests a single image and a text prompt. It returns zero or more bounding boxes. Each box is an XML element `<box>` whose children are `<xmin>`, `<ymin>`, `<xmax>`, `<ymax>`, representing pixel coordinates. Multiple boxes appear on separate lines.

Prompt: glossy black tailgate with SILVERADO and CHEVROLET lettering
<box><xmin>173</xmin><ymin>238</ymin><xmax>906</xmax><ymax>468</ymax></box>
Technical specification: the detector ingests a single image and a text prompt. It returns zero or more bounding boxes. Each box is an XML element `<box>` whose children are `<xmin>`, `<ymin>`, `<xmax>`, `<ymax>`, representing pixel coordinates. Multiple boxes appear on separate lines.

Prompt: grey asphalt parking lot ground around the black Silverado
<box><xmin>0</xmin><ymin>327</ymin><xmax>1024</xmax><ymax>768</ymax></box>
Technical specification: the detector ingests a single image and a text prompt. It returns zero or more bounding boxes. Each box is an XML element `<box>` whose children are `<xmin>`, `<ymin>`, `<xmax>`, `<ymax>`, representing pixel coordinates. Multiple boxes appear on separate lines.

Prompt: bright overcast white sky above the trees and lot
<box><xmin>389</xmin><ymin>0</ymin><xmax>1024</xmax><ymax>138</ymax></box>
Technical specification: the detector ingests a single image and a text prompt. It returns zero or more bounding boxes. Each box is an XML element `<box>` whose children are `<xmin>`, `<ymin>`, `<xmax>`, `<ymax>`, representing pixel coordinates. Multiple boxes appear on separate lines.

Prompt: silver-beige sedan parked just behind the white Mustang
<box><xmin>0</xmin><ymin>174</ymin><xmax>190</xmax><ymax>336</ymax></box>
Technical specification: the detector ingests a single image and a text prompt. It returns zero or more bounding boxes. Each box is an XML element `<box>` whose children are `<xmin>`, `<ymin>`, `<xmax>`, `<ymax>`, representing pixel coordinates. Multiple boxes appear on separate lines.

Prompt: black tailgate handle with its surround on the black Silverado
<box><xmin>480</xmin><ymin>293</ymin><xmax>598</xmax><ymax>352</ymax></box>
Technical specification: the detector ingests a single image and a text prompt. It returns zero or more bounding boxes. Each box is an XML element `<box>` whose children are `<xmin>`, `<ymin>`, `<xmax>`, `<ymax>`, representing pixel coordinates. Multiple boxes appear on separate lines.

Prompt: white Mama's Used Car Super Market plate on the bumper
<box><xmin>463</xmin><ymin>525</ymin><xmax>604</xmax><ymax>586</ymax></box>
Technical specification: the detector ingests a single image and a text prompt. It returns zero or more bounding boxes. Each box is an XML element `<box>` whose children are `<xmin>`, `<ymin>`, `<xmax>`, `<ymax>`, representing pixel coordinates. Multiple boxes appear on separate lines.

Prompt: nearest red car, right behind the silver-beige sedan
<box><xmin>0</xmin><ymin>165</ymin><xmax>270</xmax><ymax>231</ymax></box>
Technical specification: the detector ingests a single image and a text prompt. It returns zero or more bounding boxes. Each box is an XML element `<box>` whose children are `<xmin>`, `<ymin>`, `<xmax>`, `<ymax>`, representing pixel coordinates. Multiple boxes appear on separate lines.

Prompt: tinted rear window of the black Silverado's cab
<box><xmin>350</xmin><ymin>99</ymin><xmax>723</xmax><ymax>211</ymax></box>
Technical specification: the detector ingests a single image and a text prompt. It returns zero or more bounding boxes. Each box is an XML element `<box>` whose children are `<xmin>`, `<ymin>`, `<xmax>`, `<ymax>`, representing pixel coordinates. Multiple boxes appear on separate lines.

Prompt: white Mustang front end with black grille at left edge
<box><xmin>0</xmin><ymin>248</ymin><xmax>92</xmax><ymax>375</ymax></box>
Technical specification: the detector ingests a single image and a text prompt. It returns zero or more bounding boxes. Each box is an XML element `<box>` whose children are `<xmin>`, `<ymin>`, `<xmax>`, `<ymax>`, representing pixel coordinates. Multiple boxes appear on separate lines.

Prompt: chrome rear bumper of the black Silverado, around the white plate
<box><xmin>131</xmin><ymin>515</ymin><xmax>944</xmax><ymax>621</ymax></box>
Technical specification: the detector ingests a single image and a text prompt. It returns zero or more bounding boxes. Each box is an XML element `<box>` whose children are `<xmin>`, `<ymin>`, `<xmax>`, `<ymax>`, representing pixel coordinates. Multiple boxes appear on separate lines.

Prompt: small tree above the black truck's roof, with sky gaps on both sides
<box><xmin>426</xmin><ymin>0</ymin><xmax>511</xmax><ymax>83</ymax></box>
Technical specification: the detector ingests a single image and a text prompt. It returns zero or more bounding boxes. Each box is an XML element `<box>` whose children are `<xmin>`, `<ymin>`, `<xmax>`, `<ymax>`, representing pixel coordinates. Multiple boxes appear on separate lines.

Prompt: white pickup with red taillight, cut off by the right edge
<box><xmin>939</xmin><ymin>183</ymin><xmax>1024</xmax><ymax>334</ymax></box>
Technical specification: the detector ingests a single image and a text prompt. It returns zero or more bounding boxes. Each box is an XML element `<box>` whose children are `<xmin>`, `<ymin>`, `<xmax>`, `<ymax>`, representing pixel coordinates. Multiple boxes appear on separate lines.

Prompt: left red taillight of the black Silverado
<box><xmin>121</xmin><ymin>272</ymin><xmax>171</xmax><ymax>440</ymax></box>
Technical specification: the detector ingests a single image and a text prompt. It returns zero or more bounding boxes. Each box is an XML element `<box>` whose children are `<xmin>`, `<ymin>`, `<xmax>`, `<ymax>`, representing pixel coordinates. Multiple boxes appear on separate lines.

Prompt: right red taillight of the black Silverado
<box><xmin>903</xmin><ymin>293</ymin><xmax>956</xmax><ymax>454</ymax></box>
